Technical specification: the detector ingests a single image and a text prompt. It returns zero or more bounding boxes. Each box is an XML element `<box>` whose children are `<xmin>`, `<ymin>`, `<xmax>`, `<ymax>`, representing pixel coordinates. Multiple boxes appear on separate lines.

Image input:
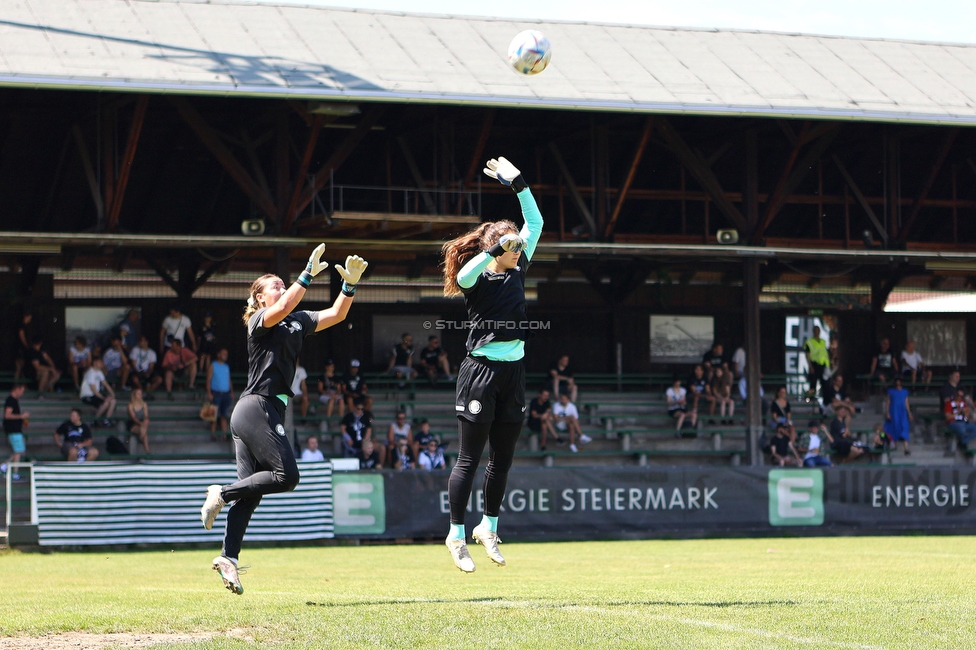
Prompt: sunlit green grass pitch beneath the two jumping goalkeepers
<box><xmin>0</xmin><ymin>537</ymin><xmax>976</xmax><ymax>649</ymax></box>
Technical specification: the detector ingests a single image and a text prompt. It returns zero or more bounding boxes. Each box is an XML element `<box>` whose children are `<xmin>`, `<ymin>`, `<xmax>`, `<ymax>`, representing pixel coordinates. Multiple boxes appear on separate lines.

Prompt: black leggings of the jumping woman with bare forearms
<box><xmin>221</xmin><ymin>395</ymin><xmax>298</xmax><ymax>560</ymax></box>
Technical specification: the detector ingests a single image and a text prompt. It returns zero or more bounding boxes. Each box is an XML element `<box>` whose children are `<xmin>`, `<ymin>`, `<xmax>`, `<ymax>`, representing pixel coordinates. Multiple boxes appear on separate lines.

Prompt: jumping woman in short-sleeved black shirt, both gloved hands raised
<box><xmin>200</xmin><ymin>244</ymin><xmax>369</xmax><ymax>595</ymax></box>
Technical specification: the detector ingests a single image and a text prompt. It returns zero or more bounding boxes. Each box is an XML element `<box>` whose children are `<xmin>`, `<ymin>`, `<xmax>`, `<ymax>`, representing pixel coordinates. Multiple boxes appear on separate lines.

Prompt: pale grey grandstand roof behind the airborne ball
<box><xmin>0</xmin><ymin>0</ymin><xmax>976</xmax><ymax>124</ymax></box>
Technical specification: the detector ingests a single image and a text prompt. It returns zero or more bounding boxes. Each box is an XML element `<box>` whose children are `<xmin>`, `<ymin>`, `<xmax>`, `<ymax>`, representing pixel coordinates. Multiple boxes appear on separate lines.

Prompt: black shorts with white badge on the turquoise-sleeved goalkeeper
<box><xmin>454</xmin><ymin>355</ymin><xmax>526</xmax><ymax>422</ymax></box>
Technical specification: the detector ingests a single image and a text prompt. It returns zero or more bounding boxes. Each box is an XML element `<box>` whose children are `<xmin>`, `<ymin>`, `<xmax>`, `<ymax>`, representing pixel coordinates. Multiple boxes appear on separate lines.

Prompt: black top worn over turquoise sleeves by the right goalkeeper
<box><xmin>461</xmin><ymin>253</ymin><xmax>529</xmax><ymax>352</ymax></box>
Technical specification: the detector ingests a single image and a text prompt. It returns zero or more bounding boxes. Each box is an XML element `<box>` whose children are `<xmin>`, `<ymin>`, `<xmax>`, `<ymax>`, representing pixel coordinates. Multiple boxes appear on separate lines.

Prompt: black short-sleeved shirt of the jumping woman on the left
<box><xmin>240</xmin><ymin>307</ymin><xmax>319</xmax><ymax>397</ymax></box>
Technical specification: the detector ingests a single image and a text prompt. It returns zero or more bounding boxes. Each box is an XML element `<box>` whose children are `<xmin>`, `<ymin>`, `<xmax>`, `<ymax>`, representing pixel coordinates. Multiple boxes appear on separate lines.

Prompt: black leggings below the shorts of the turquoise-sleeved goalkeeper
<box><xmin>448</xmin><ymin>418</ymin><xmax>522</xmax><ymax>524</ymax></box>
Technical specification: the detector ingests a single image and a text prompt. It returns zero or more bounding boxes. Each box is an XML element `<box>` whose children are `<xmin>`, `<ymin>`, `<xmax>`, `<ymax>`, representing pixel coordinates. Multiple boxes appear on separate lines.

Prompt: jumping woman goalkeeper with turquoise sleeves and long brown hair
<box><xmin>443</xmin><ymin>158</ymin><xmax>542</xmax><ymax>573</ymax></box>
